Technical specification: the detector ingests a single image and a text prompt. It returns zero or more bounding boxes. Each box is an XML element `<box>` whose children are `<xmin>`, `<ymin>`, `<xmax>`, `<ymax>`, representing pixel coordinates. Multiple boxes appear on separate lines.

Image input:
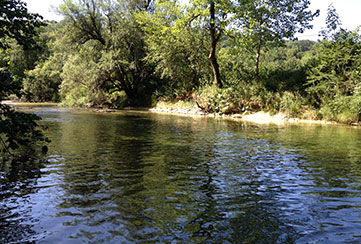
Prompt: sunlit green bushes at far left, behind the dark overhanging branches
<box><xmin>0</xmin><ymin>23</ymin><xmax>62</xmax><ymax>101</ymax></box>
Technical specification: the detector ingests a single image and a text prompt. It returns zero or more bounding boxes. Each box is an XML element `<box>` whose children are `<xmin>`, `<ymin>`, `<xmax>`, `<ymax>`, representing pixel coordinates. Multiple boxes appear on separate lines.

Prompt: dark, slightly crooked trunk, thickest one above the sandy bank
<box><xmin>208</xmin><ymin>1</ymin><xmax>223</xmax><ymax>88</ymax></box>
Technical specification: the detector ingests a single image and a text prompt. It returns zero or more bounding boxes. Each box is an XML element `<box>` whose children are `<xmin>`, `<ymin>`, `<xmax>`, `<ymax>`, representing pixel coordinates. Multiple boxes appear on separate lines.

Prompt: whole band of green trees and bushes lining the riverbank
<box><xmin>0</xmin><ymin>0</ymin><xmax>361</xmax><ymax>160</ymax></box>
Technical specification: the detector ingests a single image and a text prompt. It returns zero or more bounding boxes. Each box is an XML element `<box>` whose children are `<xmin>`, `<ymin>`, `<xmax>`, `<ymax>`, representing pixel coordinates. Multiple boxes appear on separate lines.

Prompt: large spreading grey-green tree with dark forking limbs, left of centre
<box><xmin>59</xmin><ymin>0</ymin><xmax>157</xmax><ymax>106</ymax></box>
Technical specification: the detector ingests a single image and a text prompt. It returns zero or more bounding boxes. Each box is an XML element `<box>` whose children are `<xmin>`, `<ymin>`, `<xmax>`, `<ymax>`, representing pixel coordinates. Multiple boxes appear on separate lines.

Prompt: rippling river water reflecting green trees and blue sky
<box><xmin>0</xmin><ymin>107</ymin><xmax>361</xmax><ymax>243</ymax></box>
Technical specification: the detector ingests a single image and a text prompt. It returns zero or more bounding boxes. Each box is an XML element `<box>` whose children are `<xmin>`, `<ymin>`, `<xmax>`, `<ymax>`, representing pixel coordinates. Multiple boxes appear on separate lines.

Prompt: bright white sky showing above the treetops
<box><xmin>24</xmin><ymin>0</ymin><xmax>361</xmax><ymax>40</ymax></box>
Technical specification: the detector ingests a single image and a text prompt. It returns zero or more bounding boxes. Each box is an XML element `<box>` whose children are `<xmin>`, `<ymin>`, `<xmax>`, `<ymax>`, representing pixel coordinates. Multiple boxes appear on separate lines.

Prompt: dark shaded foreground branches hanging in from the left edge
<box><xmin>0</xmin><ymin>0</ymin><xmax>44</xmax><ymax>163</ymax></box>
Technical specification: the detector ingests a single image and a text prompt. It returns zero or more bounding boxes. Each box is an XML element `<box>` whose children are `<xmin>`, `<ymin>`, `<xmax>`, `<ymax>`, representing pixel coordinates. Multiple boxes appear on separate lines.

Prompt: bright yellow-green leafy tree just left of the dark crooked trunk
<box><xmin>136</xmin><ymin>1</ymin><xmax>210</xmax><ymax>97</ymax></box>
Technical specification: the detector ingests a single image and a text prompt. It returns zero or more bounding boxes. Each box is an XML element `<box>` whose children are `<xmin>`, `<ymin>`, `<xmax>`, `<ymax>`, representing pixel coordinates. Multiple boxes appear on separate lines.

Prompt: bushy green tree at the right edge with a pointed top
<box><xmin>307</xmin><ymin>5</ymin><xmax>361</xmax><ymax>123</ymax></box>
